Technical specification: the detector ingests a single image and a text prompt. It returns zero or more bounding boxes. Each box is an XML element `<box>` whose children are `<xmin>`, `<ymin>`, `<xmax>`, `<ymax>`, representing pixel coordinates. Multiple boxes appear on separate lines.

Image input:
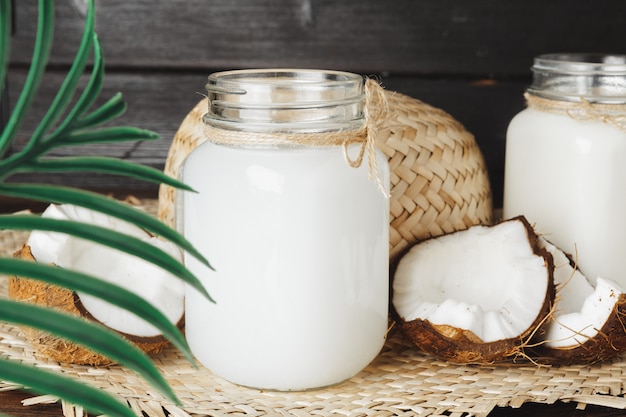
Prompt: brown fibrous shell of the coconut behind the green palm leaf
<box><xmin>8</xmin><ymin>245</ymin><xmax>184</xmax><ymax>366</ymax></box>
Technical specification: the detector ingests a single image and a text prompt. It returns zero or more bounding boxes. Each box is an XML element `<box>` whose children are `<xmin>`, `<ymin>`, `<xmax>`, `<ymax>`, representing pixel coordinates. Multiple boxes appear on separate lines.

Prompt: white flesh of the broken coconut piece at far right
<box><xmin>541</xmin><ymin>239</ymin><xmax>624</xmax><ymax>348</ymax></box>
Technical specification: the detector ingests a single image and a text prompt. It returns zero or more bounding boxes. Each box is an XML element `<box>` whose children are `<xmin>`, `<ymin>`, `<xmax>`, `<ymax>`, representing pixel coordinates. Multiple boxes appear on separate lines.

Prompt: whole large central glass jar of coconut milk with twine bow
<box><xmin>179</xmin><ymin>69</ymin><xmax>389</xmax><ymax>390</ymax></box>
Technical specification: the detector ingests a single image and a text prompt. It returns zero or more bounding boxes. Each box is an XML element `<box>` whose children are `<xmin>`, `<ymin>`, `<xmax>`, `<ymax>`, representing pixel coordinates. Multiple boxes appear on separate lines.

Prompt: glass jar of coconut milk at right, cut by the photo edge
<box><xmin>503</xmin><ymin>54</ymin><xmax>626</xmax><ymax>287</ymax></box>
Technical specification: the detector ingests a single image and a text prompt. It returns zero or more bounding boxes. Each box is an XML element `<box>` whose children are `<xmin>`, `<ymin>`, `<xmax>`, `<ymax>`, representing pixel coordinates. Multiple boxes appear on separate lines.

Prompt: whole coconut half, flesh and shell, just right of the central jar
<box><xmin>392</xmin><ymin>217</ymin><xmax>555</xmax><ymax>364</ymax></box>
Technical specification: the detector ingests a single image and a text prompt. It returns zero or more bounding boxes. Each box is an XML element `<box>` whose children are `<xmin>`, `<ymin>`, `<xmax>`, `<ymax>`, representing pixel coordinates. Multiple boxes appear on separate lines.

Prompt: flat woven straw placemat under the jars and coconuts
<box><xmin>0</xmin><ymin>203</ymin><xmax>626</xmax><ymax>417</ymax></box>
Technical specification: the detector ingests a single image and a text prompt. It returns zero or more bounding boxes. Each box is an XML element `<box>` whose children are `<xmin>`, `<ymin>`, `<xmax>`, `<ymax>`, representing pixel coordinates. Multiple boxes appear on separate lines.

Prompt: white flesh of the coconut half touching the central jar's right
<box><xmin>392</xmin><ymin>221</ymin><xmax>551</xmax><ymax>342</ymax></box>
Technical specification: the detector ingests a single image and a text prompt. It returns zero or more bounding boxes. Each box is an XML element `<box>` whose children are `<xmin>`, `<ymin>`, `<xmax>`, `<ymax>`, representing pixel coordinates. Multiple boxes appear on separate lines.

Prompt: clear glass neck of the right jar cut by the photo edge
<box><xmin>528</xmin><ymin>54</ymin><xmax>626</xmax><ymax>104</ymax></box>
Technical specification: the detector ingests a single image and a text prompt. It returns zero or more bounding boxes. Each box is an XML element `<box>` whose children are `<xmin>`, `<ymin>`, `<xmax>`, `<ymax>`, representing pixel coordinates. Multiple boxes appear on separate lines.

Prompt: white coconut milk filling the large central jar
<box><xmin>178</xmin><ymin>143</ymin><xmax>389</xmax><ymax>390</ymax></box>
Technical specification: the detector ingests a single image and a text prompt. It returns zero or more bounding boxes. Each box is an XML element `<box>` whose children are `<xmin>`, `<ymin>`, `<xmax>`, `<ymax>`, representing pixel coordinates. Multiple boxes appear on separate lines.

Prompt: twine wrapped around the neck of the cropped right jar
<box><xmin>524</xmin><ymin>93</ymin><xmax>626</xmax><ymax>132</ymax></box>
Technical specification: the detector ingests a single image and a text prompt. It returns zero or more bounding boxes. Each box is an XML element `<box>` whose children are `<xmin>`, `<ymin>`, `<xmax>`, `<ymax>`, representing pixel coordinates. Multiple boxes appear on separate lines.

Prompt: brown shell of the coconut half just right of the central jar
<box><xmin>389</xmin><ymin>216</ymin><xmax>556</xmax><ymax>364</ymax></box>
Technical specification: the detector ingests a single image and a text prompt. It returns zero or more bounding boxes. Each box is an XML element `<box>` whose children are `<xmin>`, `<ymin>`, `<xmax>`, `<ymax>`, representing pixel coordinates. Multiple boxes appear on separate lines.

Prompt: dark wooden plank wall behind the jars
<box><xmin>3</xmin><ymin>0</ymin><xmax>626</xmax><ymax>207</ymax></box>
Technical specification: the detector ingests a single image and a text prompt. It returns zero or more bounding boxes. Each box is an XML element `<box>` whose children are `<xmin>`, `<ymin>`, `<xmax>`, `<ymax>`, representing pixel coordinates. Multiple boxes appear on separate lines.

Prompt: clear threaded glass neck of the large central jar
<box><xmin>203</xmin><ymin>69</ymin><xmax>365</xmax><ymax>133</ymax></box>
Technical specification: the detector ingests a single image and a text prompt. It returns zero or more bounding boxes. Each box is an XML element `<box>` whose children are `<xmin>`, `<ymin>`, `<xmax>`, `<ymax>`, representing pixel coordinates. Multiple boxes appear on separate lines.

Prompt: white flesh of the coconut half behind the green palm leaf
<box><xmin>27</xmin><ymin>205</ymin><xmax>184</xmax><ymax>337</ymax></box>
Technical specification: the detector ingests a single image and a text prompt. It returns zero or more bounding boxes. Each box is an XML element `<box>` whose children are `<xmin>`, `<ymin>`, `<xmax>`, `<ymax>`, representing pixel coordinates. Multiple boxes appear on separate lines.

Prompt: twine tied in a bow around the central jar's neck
<box><xmin>204</xmin><ymin>78</ymin><xmax>390</xmax><ymax>198</ymax></box>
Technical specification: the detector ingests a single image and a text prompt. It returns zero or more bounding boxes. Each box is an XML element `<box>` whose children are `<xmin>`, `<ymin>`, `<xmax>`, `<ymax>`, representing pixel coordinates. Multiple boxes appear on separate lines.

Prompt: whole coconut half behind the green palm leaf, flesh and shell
<box><xmin>9</xmin><ymin>204</ymin><xmax>185</xmax><ymax>365</ymax></box>
